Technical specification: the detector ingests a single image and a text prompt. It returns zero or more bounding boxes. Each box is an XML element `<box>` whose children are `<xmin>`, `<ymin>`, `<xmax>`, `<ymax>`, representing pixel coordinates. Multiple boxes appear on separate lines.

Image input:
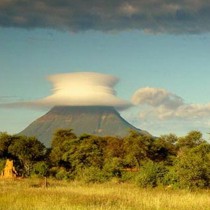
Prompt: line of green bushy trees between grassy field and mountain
<box><xmin>0</xmin><ymin>130</ymin><xmax>210</xmax><ymax>189</ymax></box>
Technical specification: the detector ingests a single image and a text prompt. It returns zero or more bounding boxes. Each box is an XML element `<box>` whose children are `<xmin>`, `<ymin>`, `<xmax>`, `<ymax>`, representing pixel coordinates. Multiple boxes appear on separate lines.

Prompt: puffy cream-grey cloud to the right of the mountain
<box><xmin>132</xmin><ymin>87</ymin><xmax>210</xmax><ymax>120</ymax></box>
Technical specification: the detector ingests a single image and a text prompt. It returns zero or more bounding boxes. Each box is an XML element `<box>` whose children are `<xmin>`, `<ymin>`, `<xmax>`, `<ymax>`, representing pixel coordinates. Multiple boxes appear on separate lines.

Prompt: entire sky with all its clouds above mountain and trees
<box><xmin>0</xmin><ymin>0</ymin><xmax>210</xmax><ymax>137</ymax></box>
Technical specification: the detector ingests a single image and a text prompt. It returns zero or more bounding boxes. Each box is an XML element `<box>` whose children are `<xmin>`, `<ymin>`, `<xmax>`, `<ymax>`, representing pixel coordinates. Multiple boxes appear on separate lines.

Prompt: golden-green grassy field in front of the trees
<box><xmin>0</xmin><ymin>179</ymin><xmax>210</xmax><ymax>210</ymax></box>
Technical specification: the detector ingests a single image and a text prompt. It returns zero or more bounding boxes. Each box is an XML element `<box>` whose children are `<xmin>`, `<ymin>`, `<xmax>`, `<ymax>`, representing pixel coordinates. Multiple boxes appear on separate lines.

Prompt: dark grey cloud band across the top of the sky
<box><xmin>0</xmin><ymin>0</ymin><xmax>210</xmax><ymax>34</ymax></box>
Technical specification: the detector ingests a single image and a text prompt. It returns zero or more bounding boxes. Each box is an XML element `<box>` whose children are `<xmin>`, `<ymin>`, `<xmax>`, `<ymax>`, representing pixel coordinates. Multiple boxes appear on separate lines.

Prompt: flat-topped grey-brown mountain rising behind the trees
<box><xmin>20</xmin><ymin>106</ymin><xmax>146</xmax><ymax>147</ymax></box>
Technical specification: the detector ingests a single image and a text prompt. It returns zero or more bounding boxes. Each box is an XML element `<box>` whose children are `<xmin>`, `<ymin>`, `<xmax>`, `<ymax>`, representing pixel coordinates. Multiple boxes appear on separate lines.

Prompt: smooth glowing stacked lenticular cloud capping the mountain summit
<box><xmin>20</xmin><ymin>72</ymin><xmax>130</xmax><ymax>108</ymax></box>
